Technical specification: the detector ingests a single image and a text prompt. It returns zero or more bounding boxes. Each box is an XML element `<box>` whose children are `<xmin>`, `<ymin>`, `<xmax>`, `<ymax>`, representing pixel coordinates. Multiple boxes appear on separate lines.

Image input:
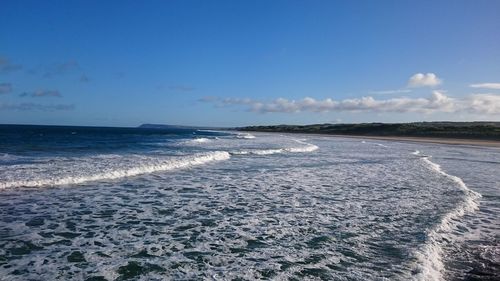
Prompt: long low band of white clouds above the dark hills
<box><xmin>200</xmin><ymin>91</ymin><xmax>500</xmax><ymax>115</ymax></box>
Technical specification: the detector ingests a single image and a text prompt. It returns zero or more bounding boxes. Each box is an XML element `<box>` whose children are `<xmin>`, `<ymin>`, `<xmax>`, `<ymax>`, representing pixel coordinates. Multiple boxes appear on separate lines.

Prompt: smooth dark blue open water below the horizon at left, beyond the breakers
<box><xmin>0</xmin><ymin>125</ymin><xmax>228</xmax><ymax>156</ymax></box>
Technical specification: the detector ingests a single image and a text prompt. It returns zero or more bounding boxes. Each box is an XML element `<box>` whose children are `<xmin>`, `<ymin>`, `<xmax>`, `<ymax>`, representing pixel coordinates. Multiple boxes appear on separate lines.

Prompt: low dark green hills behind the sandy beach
<box><xmin>238</xmin><ymin>122</ymin><xmax>500</xmax><ymax>141</ymax></box>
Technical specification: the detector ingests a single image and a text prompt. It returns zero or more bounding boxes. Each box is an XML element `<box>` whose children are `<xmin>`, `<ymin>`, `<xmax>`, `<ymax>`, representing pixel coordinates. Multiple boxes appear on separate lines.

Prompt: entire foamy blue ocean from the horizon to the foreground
<box><xmin>0</xmin><ymin>126</ymin><xmax>500</xmax><ymax>280</ymax></box>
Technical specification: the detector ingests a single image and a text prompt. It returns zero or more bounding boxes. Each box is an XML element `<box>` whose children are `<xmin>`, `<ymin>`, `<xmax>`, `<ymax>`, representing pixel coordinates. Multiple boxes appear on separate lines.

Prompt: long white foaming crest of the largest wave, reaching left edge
<box><xmin>0</xmin><ymin>151</ymin><xmax>230</xmax><ymax>189</ymax></box>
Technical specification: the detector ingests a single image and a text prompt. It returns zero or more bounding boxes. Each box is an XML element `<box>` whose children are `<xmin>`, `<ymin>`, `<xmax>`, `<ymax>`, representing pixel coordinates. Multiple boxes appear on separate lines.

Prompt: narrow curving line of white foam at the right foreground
<box><xmin>412</xmin><ymin>150</ymin><xmax>481</xmax><ymax>280</ymax></box>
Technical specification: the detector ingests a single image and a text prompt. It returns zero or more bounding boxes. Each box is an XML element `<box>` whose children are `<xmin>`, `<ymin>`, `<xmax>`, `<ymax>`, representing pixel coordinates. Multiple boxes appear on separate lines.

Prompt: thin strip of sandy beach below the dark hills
<box><xmin>240</xmin><ymin>131</ymin><xmax>500</xmax><ymax>148</ymax></box>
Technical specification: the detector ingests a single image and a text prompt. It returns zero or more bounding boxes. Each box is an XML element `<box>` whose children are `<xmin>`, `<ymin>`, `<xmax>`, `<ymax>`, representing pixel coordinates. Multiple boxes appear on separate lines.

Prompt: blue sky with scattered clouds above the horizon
<box><xmin>0</xmin><ymin>0</ymin><xmax>500</xmax><ymax>126</ymax></box>
